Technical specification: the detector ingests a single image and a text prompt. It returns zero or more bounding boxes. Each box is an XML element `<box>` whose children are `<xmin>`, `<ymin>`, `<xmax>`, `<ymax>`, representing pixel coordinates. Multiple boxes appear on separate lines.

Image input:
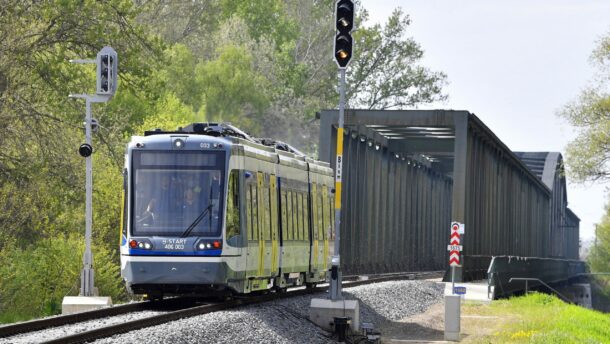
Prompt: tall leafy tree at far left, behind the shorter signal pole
<box><xmin>0</xmin><ymin>0</ymin><xmax>164</xmax><ymax>321</ymax></box>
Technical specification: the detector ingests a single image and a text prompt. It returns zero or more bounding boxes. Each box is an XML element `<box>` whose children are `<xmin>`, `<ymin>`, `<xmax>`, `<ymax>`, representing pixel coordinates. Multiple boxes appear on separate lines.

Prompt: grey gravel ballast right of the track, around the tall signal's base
<box><xmin>90</xmin><ymin>281</ymin><xmax>444</xmax><ymax>344</ymax></box>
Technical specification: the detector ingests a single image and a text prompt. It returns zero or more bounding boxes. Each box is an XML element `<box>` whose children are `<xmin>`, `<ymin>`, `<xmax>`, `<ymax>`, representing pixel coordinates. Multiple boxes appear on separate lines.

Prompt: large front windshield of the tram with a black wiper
<box><xmin>132</xmin><ymin>151</ymin><xmax>225</xmax><ymax>237</ymax></box>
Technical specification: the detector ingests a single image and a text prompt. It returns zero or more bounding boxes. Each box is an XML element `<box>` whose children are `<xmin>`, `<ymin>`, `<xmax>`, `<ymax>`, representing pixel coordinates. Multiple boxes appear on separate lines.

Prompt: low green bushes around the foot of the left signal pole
<box><xmin>0</xmin><ymin>235</ymin><xmax>125</xmax><ymax>322</ymax></box>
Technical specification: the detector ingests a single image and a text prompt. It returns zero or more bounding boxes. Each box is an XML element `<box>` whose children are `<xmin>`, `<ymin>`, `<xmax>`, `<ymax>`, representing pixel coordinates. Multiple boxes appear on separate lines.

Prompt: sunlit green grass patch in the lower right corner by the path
<box><xmin>462</xmin><ymin>293</ymin><xmax>610</xmax><ymax>344</ymax></box>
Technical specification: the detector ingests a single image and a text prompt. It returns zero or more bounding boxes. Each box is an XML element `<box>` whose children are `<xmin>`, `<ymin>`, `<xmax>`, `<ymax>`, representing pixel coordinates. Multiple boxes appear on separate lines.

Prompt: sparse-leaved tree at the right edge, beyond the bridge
<box><xmin>560</xmin><ymin>33</ymin><xmax>610</xmax><ymax>182</ymax></box>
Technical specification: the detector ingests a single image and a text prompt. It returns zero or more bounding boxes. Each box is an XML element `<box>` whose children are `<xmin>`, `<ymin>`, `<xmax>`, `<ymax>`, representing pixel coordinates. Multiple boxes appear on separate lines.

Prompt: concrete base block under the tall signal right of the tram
<box><xmin>309</xmin><ymin>299</ymin><xmax>360</xmax><ymax>332</ymax></box>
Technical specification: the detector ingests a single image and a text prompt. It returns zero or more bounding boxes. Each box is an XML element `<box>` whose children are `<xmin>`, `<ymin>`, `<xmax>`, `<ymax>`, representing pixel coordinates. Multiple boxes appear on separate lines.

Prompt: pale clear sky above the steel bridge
<box><xmin>364</xmin><ymin>0</ymin><xmax>610</xmax><ymax>240</ymax></box>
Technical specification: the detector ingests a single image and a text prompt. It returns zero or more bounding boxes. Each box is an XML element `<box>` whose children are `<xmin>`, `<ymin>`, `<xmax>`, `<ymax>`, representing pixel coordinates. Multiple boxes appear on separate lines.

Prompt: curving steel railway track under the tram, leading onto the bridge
<box><xmin>0</xmin><ymin>271</ymin><xmax>436</xmax><ymax>343</ymax></box>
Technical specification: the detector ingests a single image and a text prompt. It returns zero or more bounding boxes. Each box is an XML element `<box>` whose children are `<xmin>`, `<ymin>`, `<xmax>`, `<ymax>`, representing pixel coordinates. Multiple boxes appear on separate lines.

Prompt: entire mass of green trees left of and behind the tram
<box><xmin>0</xmin><ymin>0</ymin><xmax>444</xmax><ymax>321</ymax></box>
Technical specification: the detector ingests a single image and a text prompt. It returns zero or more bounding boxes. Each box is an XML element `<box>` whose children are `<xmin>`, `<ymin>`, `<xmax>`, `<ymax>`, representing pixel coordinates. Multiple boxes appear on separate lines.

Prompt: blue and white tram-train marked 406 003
<box><xmin>120</xmin><ymin>123</ymin><xmax>335</xmax><ymax>299</ymax></box>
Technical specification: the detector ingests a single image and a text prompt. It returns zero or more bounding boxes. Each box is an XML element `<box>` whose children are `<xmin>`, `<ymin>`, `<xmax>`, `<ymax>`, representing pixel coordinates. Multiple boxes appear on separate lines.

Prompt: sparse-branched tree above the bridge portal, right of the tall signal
<box><xmin>348</xmin><ymin>8</ymin><xmax>446</xmax><ymax>110</ymax></box>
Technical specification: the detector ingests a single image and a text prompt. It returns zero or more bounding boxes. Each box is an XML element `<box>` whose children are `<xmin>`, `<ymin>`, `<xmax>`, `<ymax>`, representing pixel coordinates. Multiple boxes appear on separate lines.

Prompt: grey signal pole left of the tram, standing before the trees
<box><xmin>69</xmin><ymin>47</ymin><xmax>118</xmax><ymax>296</ymax></box>
